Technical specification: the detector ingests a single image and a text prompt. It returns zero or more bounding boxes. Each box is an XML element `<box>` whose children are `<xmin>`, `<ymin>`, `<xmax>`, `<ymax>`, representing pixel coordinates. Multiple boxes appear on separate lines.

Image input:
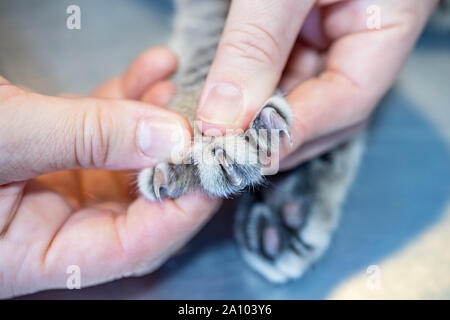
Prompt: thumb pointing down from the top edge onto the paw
<box><xmin>197</xmin><ymin>0</ymin><xmax>315</xmax><ymax>131</ymax></box>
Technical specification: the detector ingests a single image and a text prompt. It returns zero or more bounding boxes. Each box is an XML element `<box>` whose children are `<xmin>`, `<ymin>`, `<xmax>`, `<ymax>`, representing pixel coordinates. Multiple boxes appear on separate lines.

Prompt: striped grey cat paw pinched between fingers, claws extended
<box><xmin>138</xmin><ymin>95</ymin><xmax>292</xmax><ymax>201</ymax></box>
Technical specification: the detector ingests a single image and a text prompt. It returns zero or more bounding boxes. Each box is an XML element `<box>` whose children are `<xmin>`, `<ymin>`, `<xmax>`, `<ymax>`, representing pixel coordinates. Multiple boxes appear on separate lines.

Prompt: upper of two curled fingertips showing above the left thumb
<box><xmin>91</xmin><ymin>47</ymin><xmax>178</xmax><ymax>100</ymax></box>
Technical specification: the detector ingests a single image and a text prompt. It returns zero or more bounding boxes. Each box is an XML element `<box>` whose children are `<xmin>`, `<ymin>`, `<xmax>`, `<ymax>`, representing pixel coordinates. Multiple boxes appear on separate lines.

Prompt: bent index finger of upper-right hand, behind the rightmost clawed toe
<box><xmin>288</xmin><ymin>0</ymin><xmax>438</xmax><ymax>156</ymax></box>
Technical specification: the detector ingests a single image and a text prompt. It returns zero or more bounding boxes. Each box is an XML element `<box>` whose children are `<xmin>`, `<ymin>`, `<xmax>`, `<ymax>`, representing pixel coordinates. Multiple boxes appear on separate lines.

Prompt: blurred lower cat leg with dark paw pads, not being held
<box><xmin>234</xmin><ymin>137</ymin><xmax>363</xmax><ymax>282</ymax></box>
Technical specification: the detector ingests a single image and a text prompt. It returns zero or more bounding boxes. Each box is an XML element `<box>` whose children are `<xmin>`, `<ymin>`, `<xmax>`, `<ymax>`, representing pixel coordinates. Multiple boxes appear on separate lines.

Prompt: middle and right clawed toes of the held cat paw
<box><xmin>193</xmin><ymin>95</ymin><xmax>292</xmax><ymax>198</ymax></box>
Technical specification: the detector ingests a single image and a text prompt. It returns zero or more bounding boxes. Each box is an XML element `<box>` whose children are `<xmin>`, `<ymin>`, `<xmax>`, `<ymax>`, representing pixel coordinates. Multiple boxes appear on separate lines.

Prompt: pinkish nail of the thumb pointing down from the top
<box><xmin>198</xmin><ymin>82</ymin><xmax>243</xmax><ymax>125</ymax></box>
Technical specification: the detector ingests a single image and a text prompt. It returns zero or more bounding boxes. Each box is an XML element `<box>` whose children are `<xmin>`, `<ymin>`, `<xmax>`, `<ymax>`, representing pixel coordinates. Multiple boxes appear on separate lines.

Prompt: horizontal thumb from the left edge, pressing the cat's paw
<box><xmin>0</xmin><ymin>83</ymin><xmax>190</xmax><ymax>185</ymax></box>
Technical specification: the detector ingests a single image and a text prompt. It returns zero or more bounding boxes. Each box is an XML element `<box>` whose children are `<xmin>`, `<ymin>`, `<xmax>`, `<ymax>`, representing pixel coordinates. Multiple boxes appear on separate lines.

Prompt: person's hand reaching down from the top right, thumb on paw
<box><xmin>197</xmin><ymin>0</ymin><xmax>437</xmax><ymax>168</ymax></box>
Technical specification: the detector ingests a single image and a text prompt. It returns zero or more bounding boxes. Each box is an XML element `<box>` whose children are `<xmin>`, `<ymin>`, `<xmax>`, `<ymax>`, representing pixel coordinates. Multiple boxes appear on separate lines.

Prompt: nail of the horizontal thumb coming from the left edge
<box><xmin>137</xmin><ymin>117</ymin><xmax>185</xmax><ymax>159</ymax></box>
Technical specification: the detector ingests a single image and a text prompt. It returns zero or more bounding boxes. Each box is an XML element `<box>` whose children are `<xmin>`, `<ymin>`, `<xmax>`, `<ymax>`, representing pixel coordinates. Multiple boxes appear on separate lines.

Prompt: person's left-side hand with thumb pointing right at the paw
<box><xmin>0</xmin><ymin>48</ymin><xmax>218</xmax><ymax>297</ymax></box>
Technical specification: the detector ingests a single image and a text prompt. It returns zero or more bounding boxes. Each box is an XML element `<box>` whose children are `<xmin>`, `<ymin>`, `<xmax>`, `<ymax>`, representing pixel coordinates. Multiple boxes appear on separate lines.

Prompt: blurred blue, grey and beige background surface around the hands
<box><xmin>0</xmin><ymin>0</ymin><xmax>450</xmax><ymax>299</ymax></box>
